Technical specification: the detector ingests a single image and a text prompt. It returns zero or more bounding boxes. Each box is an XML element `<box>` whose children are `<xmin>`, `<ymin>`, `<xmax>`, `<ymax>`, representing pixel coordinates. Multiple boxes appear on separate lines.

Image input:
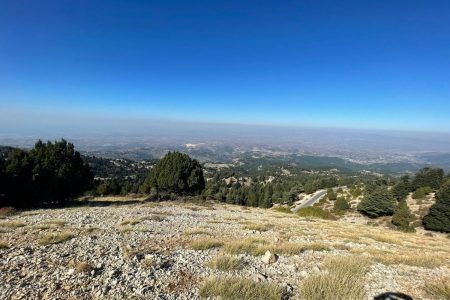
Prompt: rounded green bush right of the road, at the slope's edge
<box><xmin>357</xmin><ymin>186</ymin><xmax>396</xmax><ymax>218</ymax></box>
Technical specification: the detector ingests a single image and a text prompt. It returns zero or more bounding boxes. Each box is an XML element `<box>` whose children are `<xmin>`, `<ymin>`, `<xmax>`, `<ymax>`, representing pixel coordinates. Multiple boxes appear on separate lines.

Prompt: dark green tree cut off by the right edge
<box><xmin>422</xmin><ymin>180</ymin><xmax>450</xmax><ymax>232</ymax></box>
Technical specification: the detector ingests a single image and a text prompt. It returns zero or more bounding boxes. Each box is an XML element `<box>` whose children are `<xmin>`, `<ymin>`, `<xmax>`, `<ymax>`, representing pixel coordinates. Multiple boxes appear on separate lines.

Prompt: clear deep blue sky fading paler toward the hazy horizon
<box><xmin>0</xmin><ymin>0</ymin><xmax>450</xmax><ymax>131</ymax></box>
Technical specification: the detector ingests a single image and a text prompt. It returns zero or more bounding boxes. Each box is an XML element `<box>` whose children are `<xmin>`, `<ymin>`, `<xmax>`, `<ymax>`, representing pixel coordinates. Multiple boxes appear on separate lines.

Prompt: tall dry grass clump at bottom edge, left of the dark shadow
<box><xmin>300</xmin><ymin>256</ymin><xmax>369</xmax><ymax>300</ymax></box>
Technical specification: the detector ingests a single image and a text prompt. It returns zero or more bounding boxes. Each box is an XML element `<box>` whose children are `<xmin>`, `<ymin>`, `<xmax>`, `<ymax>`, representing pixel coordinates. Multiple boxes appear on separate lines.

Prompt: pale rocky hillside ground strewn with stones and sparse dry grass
<box><xmin>0</xmin><ymin>201</ymin><xmax>450</xmax><ymax>299</ymax></box>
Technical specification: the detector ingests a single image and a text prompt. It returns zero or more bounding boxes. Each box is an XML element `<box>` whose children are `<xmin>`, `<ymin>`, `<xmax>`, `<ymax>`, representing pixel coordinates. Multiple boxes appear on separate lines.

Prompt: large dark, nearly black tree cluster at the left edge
<box><xmin>0</xmin><ymin>140</ymin><xmax>93</xmax><ymax>207</ymax></box>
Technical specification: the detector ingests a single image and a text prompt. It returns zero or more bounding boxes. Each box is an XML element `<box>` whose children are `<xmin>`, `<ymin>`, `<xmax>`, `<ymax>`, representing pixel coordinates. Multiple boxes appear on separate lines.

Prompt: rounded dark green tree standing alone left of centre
<box><xmin>143</xmin><ymin>152</ymin><xmax>205</xmax><ymax>194</ymax></box>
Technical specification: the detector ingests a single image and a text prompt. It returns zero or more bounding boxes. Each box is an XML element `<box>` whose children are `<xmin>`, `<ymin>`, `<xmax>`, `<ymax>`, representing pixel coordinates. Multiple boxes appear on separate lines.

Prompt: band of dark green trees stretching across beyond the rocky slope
<box><xmin>0</xmin><ymin>139</ymin><xmax>450</xmax><ymax>232</ymax></box>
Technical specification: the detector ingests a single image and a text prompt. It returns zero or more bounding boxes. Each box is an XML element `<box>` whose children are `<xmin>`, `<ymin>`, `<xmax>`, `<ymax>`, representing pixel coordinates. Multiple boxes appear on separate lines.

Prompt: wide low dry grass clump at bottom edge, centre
<box><xmin>200</xmin><ymin>277</ymin><xmax>282</xmax><ymax>300</ymax></box>
